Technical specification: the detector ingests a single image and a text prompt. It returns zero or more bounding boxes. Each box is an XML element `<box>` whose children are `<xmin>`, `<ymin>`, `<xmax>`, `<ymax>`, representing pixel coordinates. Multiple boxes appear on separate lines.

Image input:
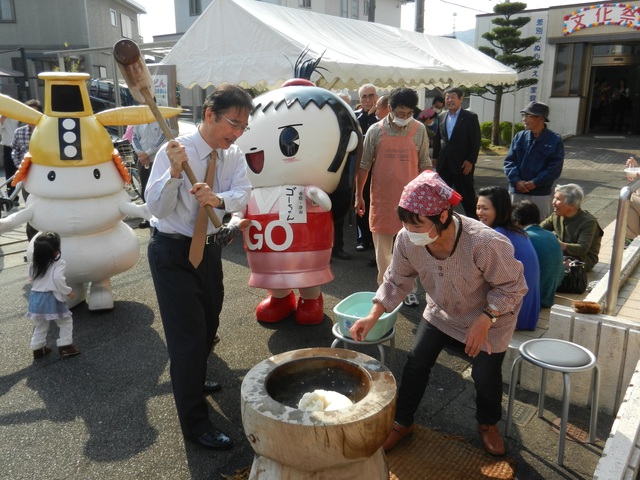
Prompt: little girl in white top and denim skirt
<box><xmin>27</xmin><ymin>232</ymin><xmax>80</xmax><ymax>358</ymax></box>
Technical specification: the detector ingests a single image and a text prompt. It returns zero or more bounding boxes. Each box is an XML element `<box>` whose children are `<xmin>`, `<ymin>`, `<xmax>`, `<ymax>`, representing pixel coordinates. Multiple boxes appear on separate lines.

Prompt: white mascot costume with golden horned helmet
<box><xmin>0</xmin><ymin>72</ymin><xmax>181</xmax><ymax>310</ymax></box>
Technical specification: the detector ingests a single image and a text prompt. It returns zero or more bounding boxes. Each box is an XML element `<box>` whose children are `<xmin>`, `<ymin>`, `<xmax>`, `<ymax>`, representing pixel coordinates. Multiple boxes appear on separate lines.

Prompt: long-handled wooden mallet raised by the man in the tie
<box><xmin>113</xmin><ymin>38</ymin><xmax>222</xmax><ymax>228</ymax></box>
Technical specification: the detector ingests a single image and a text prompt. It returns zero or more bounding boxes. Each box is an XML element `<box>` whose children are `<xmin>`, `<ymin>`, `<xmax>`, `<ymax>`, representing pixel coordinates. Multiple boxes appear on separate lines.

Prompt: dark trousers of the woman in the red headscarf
<box><xmin>396</xmin><ymin>319</ymin><xmax>505</xmax><ymax>427</ymax></box>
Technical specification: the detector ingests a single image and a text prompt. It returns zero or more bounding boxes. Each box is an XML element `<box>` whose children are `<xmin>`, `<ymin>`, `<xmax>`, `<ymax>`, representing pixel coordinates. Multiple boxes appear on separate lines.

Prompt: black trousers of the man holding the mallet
<box><xmin>148</xmin><ymin>229</ymin><xmax>224</xmax><ymax>439</ymax></box>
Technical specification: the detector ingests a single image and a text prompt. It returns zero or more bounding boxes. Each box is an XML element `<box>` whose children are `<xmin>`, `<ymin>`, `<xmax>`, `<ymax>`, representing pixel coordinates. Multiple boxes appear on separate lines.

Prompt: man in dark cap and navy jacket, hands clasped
<box><xmin>504</xmin><ymin>102</ymin><xmax>564</xmax><ymax>219</ymax></box>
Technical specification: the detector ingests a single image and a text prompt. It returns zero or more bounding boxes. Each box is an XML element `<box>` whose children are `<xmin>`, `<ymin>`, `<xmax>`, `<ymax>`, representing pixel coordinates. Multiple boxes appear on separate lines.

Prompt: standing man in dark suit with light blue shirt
<box><xmin>433</xmin><ymin>88</ymin><xmax>480</xmax><ymax>219</ymax></box>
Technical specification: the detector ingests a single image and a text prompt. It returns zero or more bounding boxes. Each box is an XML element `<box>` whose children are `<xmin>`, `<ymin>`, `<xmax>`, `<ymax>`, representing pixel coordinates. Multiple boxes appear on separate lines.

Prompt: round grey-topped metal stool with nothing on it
<box><xmin>505</xmin><ymin>338</ymin><xmax>600</xmax><ymax>465</ymax></box>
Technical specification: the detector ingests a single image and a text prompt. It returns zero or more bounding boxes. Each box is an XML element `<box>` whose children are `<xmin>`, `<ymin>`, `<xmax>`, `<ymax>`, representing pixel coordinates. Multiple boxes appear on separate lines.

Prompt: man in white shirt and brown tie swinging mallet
<box><xmin>145</xmin><ymin>84</ymin><xmax>253</xmax><ymax>450</ymax></box>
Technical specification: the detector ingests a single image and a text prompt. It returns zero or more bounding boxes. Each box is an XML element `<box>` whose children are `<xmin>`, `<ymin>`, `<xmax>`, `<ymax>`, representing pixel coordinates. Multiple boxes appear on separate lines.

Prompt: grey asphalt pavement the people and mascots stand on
<box><xmin>0</xmin><ymin>133</ymin><xmax>640</xmax><ymax>480</ymax></box>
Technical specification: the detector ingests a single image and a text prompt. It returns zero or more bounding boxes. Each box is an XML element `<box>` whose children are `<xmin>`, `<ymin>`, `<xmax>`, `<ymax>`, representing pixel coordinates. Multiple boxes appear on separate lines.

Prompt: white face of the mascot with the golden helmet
<box><xmin>25</xmin><ymin>162</ymin><xmax>124</xmax><ymax>199</ymax></box>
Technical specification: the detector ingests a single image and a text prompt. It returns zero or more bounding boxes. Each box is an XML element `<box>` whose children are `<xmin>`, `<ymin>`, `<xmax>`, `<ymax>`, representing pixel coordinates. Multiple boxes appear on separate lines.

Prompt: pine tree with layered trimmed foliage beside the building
<box><xmin>470</xmin><ymin>1</ymin><xmax>542</xmax><ymax>145</ymax></box>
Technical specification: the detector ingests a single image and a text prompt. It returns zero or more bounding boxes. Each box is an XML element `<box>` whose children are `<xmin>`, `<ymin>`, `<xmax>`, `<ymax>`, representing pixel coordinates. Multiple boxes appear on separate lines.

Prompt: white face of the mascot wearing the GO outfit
<box><xmin>237</xmin><ymin>86</ymin><xmax>357</xmax><ymax>193</ymax></box>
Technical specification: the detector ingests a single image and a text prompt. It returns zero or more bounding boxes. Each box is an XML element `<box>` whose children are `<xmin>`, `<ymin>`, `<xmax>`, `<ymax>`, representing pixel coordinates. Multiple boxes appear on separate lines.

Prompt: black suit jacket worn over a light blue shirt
<box><xmin>433</xmin><ymin>109</ymin><xmax>480</xmax><ymax>175</ymax></box>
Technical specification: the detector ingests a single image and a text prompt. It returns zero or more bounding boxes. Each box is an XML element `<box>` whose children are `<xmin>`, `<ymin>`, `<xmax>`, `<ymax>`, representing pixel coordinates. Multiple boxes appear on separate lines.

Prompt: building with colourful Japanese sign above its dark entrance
<box><xmin>471</xmin><ymin>1</ymin><xmax>640</xmax><ymax>135</ymax></box>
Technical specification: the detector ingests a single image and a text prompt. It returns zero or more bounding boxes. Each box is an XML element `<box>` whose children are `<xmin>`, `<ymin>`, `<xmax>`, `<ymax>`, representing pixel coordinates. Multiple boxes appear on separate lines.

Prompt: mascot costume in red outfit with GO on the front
<box><xmin>237</xmin><ymin>79</ymin><xmax>362</xmax><ymax>325</ymax></box>
